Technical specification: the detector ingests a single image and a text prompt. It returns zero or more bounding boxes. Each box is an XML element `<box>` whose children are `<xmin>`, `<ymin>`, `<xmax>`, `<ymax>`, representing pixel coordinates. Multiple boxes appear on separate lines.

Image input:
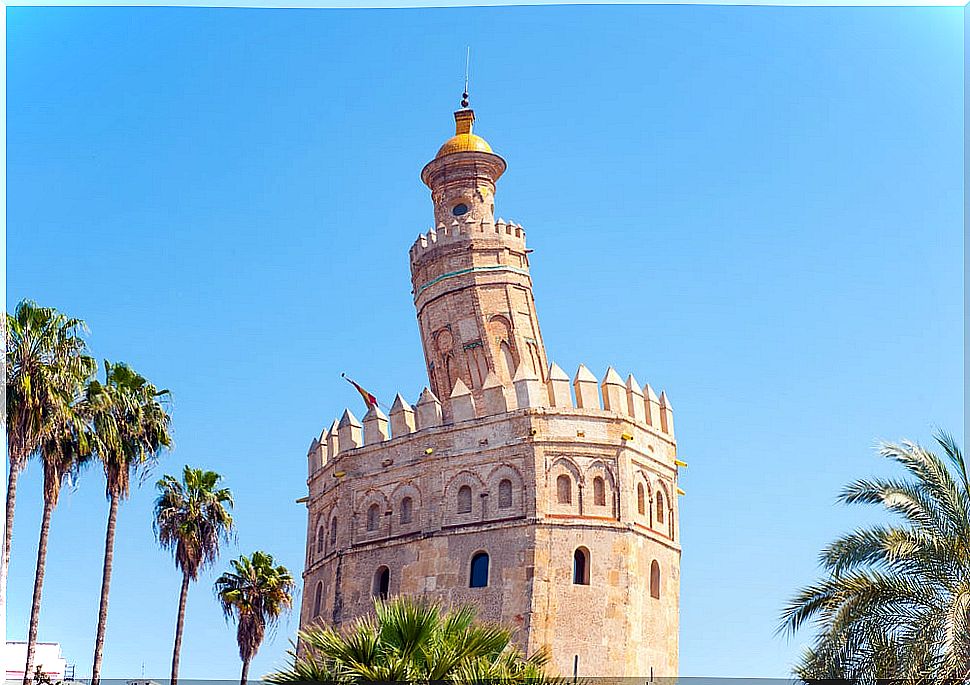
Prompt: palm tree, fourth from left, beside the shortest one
<box><xmin>154</xmin><ymin>466</ymin><xmax>233</xmax><ymax>685</ymax></box>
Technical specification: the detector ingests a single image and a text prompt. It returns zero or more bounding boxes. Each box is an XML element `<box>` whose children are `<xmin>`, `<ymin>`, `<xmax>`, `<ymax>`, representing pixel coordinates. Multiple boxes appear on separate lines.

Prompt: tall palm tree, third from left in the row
<box><xmin>86</xmin><ymin>361</ymin><xmax>172</xmax><ymax>685</ymax></box>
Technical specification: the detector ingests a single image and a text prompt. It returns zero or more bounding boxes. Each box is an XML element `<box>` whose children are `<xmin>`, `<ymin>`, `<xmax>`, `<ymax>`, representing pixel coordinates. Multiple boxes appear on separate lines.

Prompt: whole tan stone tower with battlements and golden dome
<box><xmin>300</xmin><ymin>103</ymin><xmax>683</xmax><ymax>677</ymax></box>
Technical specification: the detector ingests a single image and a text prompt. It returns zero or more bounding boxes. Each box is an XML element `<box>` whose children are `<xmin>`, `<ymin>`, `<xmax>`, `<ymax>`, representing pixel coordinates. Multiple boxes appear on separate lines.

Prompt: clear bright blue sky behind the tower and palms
<box><xmin>7</xmin><ymin>6</ymin><xmax>964</xmax><ymax>678</ymax></box>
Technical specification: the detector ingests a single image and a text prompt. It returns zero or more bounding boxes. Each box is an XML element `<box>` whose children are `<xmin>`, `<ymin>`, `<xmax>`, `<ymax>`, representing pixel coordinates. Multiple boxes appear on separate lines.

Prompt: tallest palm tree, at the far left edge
<box><xmin>0</xmin><ymin>300</ymin><xmax>94</xmax><ymax>632</ymax></box>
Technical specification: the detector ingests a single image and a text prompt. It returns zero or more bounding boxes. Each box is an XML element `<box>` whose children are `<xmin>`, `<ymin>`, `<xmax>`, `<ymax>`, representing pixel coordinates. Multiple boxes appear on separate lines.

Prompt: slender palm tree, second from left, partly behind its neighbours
<box><xmin>24</xmin><ymin>401</ymin><xmax>91</xmax><ymax>685</ymax></box>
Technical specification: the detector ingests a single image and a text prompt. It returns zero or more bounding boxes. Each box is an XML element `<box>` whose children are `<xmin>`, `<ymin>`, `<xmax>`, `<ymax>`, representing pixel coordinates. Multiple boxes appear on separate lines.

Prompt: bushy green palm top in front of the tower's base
<box><xmin>264</xmin><ymin>596</ymin><xmax>561</xmax><ymax>685</ymax></box>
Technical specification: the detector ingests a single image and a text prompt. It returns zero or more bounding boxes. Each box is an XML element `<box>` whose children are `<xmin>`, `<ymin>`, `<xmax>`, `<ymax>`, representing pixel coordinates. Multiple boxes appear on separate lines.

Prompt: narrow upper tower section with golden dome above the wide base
<box><xmin>411</xmin><ymin>109</ymin><xmax>547</xmax><ymax>411</ymax></box>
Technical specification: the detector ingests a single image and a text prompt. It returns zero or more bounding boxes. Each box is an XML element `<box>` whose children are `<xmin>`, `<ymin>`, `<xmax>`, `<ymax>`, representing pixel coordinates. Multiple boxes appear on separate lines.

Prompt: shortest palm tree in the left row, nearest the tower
<box><xmin>215</xmin><ymin>552</ymin><xmax>296</xmax><ymax>685</ymax></box>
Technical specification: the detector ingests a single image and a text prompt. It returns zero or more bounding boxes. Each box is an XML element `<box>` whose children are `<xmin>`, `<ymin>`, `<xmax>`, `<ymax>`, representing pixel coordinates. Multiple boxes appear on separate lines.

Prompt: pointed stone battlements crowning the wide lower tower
<box><xmin>307</xmin><ymin>364</ymin><xmax>674</xmax><ymax>477</ymax></box>
